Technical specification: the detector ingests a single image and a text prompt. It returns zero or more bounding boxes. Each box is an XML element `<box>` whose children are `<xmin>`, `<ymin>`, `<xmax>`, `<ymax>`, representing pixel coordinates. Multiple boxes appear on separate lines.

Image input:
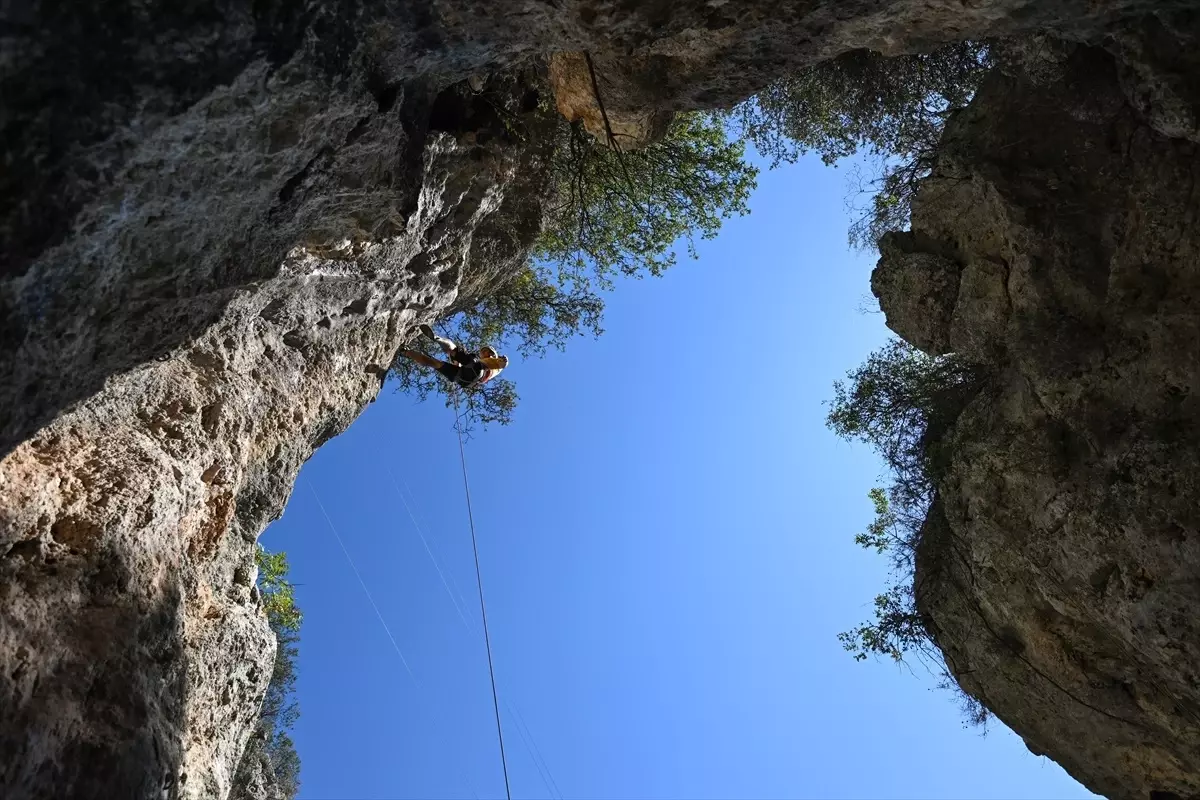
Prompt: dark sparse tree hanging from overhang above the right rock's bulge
<box><xmin>727</xmin><ymin>42</ymin><xmax>992</xmax><ymax>248</ymax></box>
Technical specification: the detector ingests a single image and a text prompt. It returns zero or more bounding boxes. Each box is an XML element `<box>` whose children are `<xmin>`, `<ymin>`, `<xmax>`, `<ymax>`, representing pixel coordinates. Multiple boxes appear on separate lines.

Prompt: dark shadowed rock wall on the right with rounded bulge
<box><xmin>872</xmin><ymin>23</ymin><xmax>1200</xmax><ymax>800</ymax></box>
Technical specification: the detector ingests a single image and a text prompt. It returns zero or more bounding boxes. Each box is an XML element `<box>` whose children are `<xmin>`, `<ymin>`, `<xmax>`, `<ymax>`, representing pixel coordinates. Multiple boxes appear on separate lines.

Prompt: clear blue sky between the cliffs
<box><xmin>263</xmin><ymin>151</ymin><xmax>1092</xmax><ymax>800</ymax></box>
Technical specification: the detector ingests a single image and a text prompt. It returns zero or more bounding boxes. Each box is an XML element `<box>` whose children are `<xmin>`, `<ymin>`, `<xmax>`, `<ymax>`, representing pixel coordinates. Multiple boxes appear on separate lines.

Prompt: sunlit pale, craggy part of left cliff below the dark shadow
<box><xmin>0</xmin><ymin>57</ymin><xmax>552</xmax><ymax>798</ymax></box>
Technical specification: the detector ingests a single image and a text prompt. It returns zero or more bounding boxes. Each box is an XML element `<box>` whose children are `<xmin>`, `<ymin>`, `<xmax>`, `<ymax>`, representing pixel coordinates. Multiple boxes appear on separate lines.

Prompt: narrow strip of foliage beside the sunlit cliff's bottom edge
<box><xmin>234</xmin><ymin>546</ymin><xmax>304</xmax><ymax>800</ymax></box>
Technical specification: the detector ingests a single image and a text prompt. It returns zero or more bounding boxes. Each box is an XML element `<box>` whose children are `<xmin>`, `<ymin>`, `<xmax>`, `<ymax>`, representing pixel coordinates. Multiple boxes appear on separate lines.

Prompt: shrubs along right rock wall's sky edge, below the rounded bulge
<box><xmin>827</xmin><ymin>339</ymin><xmax>986</xmax><ymax>723</ymax></box>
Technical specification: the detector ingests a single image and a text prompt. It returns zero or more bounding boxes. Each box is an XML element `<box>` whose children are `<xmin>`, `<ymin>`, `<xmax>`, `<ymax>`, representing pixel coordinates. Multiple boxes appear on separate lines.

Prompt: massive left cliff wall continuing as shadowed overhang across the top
<box><xmin>0</xmin><ymin>0</ymin><xmax>1196</xmax><ymax>799</ymax></box>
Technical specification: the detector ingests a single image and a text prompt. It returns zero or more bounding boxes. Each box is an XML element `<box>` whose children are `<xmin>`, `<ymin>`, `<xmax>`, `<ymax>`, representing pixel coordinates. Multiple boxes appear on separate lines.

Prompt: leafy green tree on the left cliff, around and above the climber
<box><xmin>391</xmin><ymin>113</ymin><xmax>757</xmax><ymax>425</ymax></box>
